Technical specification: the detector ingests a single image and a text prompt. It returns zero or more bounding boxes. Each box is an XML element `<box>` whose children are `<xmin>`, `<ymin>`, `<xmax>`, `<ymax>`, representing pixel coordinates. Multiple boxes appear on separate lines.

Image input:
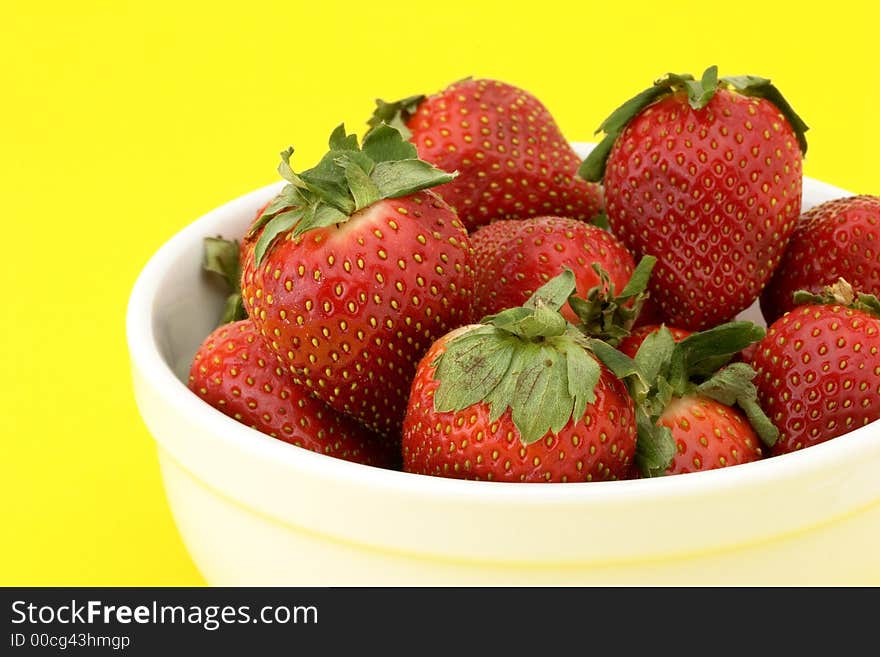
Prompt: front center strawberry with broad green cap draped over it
<box><xmin>403</xmin><ymin>270</ymin><xmax>636</xmax><ymax>482</ymax></box>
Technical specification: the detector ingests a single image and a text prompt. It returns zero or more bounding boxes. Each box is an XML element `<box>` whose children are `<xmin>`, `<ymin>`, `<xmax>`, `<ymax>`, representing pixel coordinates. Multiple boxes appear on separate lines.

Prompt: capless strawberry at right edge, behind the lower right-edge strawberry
<box><xmin>761</xmin><ymin>196</ymin><xmax>880</xmax><ymax>324</ymax></box>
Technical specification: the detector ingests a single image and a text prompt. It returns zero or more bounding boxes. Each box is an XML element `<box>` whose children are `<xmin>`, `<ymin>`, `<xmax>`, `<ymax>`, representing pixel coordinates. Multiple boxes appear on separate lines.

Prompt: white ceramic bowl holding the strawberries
<box><xmin>127</xmin><ymin>145</ymin><xmax>880</xmax><ymax>585</ymax></box>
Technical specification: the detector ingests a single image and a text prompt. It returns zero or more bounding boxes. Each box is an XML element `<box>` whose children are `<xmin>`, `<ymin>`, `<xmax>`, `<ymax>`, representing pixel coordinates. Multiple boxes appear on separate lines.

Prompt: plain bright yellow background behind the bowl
<box><xmin>0</xmin><ymin>0</ymin><xmax>880</xmax><ymax>585</ymax></box>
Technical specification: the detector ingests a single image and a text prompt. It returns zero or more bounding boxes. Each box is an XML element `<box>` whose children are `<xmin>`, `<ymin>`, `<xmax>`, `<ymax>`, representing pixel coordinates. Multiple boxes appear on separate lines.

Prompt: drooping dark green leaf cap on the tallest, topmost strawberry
<box><xmin>578</xmin><ymin>66</ymin><xmax>809</xmax><ymax>182</ymax></box>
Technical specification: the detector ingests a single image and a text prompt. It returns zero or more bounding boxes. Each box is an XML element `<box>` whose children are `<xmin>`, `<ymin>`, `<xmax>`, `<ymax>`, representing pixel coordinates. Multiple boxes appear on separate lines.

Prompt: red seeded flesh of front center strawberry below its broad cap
<box><xmin>403</xmin><ymin>328</ymin><xmax>636</xmax><ymax>482</ymax></box>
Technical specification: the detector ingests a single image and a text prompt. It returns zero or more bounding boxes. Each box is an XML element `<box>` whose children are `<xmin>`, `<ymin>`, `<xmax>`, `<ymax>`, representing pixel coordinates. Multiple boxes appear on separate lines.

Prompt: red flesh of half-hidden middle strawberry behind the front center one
<box><xmin>473</xmin><ymin>216</ymin><xmax>635</xmax><ymax>322</ymax></box>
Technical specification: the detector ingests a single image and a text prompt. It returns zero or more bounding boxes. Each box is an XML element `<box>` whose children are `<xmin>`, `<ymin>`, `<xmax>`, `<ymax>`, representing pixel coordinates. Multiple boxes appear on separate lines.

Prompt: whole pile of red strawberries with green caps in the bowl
<box><xmin>189</xmin><ymin>67</ymin><xmax>880</xmax><ymax>482</ymax></box>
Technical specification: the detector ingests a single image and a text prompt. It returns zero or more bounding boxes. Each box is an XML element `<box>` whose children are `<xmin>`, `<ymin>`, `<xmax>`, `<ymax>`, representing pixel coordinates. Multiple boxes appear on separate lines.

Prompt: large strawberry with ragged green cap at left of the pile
<box><xmin>242</xmin><ymin>126</ymin><xmax>474</xmax><ymax>435</ymax></box>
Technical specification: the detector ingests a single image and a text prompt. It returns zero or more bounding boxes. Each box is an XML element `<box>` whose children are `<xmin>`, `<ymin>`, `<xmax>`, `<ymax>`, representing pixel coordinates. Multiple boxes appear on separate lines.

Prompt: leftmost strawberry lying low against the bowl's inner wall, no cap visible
<box><xmin>189</xmin><ymin>320</ymin><xmax>399</xmax><ymax>467</ymax></box>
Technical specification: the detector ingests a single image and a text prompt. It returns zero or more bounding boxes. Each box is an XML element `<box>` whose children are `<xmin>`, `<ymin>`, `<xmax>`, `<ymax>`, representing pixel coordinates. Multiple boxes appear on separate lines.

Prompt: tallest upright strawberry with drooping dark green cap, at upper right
<box><xmin>579</xmin><ymin>66</ymin><xmax>807</xmax><ymax>330</ymax></box>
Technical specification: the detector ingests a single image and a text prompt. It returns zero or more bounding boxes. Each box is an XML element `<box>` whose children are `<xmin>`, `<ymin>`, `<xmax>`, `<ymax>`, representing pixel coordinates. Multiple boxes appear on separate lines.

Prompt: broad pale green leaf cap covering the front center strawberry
<box><xmin>432</xmin><ymin>269</ymin><xmax>602</xmax><ymax>445</ymax></box>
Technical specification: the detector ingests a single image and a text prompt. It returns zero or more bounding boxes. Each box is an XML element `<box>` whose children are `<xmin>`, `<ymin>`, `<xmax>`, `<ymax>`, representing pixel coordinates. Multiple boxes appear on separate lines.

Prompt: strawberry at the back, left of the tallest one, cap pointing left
<box><xmin>369</xmin><ymin>79</ymin><xmax>602</xmax><ymax>231</ymax></box>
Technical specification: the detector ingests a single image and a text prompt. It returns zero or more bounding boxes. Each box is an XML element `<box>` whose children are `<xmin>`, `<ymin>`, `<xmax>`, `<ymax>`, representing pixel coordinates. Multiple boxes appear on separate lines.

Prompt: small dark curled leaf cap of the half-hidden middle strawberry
<box><xmin>569</xmin><ymin>255</ymin><xmax>657</xmax><ymax>346</ymax></box>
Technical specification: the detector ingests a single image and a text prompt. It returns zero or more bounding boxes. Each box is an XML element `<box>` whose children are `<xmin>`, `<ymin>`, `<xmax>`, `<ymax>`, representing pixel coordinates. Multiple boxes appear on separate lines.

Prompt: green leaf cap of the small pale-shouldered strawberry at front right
<box><xmin>590</xmin><ymin>321</ymin><xmax>779</xmax><ymax>477</ymax></box>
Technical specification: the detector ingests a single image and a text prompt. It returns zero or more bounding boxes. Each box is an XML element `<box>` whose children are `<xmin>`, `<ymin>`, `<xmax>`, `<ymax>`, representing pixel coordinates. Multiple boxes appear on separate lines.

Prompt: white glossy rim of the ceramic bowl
<box><xmin>125</xmin><ymin>155</ymin><xmax>880</xmax><ymax>505</ymax></box>
